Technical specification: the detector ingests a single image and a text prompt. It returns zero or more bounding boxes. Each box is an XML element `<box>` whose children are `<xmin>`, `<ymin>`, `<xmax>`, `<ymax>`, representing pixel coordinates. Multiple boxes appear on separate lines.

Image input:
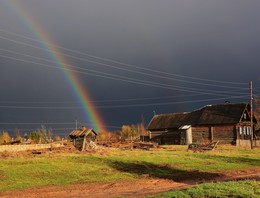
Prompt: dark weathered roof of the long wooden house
<box><xmin>147</xmin><ymin>103</ymin><xmax>249</xmax><ymax>130</ymax></box>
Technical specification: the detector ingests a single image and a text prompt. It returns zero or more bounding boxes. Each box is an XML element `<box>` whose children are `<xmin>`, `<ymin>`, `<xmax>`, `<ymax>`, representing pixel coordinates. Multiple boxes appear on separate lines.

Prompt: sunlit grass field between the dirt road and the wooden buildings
<box><xmin>0</xmin><ymin>146</ymin><xmax>260</xmax><ymax>197</ymax></box>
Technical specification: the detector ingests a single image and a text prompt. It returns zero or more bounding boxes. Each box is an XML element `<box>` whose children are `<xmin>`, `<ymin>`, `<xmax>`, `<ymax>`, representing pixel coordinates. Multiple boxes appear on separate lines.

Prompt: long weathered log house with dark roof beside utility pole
<box><xmin>147</xmin><ymin>103</ymin><xmax>256</xmax><ymax>144</ymax></box>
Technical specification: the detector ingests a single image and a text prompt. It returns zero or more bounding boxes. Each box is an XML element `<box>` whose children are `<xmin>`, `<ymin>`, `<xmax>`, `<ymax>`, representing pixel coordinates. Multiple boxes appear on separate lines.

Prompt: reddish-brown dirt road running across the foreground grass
<box><xmin>0</xmin><ymin>170</ymin><xmax>260</xmax><ymax>198</ymax></box>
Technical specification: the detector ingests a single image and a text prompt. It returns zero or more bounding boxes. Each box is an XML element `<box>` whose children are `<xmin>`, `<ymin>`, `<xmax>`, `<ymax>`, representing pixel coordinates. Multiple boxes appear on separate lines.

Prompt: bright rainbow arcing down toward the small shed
<box><xmin>5</xmin><ymin>0</ymin><xmax>106</xmax><ymax>132</ymax></box>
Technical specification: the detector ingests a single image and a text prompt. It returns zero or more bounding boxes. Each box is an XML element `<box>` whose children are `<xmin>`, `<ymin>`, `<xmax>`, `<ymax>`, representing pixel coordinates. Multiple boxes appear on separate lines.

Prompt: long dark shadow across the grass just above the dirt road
<box><xmin>102</xmin><ymin>160</ymin><xmax>222</xmax><ymax>182</ymax></box>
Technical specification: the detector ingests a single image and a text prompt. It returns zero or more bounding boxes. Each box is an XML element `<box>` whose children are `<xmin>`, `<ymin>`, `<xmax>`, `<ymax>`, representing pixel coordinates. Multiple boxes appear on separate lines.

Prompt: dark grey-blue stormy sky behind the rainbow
<box><xmin>0</xmin><ymin>0</ymin><xmax>260</xmax><ymax>135</ymax></box>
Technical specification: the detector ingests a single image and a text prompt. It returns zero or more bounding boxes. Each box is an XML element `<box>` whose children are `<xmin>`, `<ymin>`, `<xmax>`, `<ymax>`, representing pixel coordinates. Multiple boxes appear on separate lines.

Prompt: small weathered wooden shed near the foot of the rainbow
<box><xmin>69</xmin><ymin>127</ymin><xmax>97</xmax><ymax>151</ymax></box>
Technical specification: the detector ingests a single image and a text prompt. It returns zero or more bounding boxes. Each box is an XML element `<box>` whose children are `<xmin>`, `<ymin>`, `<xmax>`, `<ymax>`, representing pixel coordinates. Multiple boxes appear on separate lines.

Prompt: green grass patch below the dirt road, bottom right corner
<box><xmin>148</xmin><ymin>180</ymin><xmax>260</xmax><ymax>198</ymax></box>
